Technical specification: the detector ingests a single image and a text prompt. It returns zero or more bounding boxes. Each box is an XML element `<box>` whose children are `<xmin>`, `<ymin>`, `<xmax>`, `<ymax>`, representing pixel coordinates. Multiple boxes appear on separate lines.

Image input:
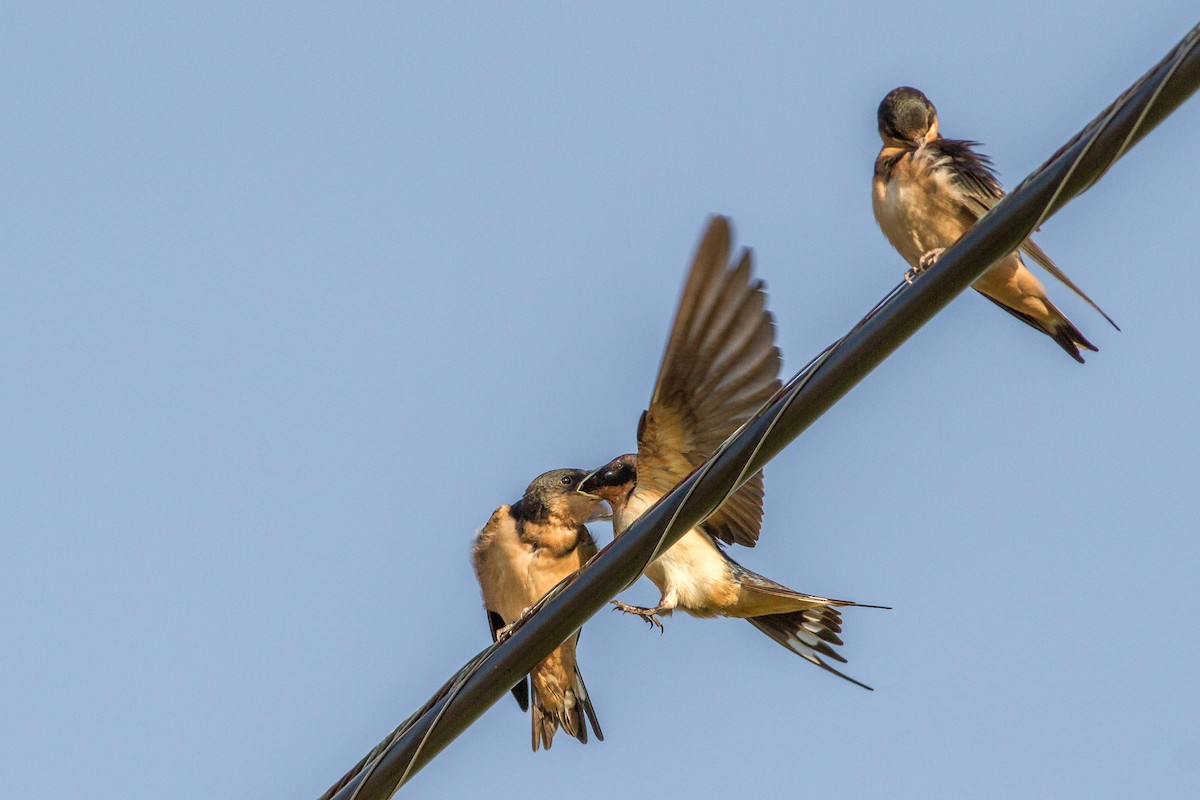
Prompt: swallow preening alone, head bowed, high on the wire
<box><xmin>871</xmin><ymin>86</ymin><xmax>1121</xmax><ymax>363</ymax></box>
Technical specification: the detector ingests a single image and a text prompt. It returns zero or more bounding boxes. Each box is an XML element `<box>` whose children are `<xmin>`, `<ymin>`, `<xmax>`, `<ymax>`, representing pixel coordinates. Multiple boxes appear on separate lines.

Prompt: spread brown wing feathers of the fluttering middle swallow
<box><xmin>637</xmin><ymin>217</ymin><xmax>781</xmax><ymax>547</ymax></box>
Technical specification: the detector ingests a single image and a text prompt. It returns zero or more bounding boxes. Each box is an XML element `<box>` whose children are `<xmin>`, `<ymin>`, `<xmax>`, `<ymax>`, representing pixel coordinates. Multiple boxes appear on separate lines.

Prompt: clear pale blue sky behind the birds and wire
<box><xmin>0</xmin><ymin>0</ymin><xmax>1200</xmax><ymax>800</ymax></box>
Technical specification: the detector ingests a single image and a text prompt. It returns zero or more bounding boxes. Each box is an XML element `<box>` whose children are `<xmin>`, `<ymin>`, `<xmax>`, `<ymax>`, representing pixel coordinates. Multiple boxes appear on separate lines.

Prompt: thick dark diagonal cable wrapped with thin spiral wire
<box><xmin>320</xmin><ymin>20</ymin><xmax>1200</xmax><ymax>800</ymax></box>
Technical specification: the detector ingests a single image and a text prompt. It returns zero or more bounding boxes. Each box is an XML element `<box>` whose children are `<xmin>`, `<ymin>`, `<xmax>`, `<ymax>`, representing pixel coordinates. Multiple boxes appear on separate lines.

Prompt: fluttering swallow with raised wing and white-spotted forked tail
<box><xmin>580</xmin><ymin>217</ymin><xmax>870</xmax><ymax>688</ymax></box>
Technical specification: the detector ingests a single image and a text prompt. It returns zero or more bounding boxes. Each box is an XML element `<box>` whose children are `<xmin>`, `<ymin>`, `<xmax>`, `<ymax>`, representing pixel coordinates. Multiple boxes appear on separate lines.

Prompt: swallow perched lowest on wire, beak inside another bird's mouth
<box><xmin>470</xmin><ymin>469</ymin><xmax>604</xmax><ymax>752</ymax></box>
